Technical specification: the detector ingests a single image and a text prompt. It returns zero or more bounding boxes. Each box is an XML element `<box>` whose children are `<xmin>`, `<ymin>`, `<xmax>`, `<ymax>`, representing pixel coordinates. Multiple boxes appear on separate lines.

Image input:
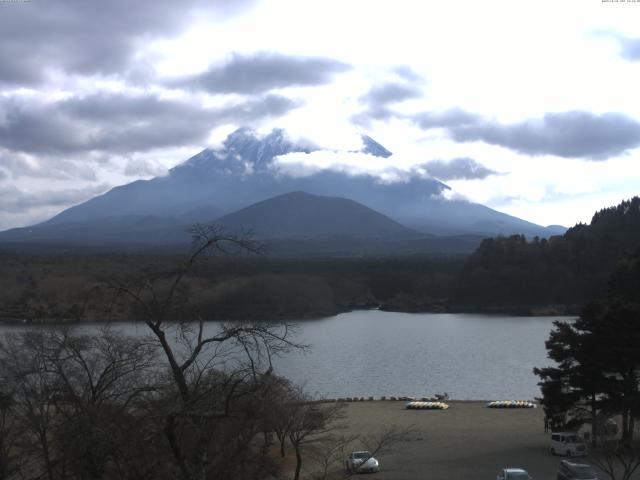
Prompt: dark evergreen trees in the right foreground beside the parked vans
<box><xmin>534</xmin><ymin>250</ymin><xmax>640</xmax><ymax>479</ymax></box>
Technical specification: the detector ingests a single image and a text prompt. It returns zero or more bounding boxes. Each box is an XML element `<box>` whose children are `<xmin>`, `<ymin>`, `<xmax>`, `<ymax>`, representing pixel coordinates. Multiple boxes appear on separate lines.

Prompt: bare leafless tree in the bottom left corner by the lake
<box><xmin>0</xmin><ymin>329</ymin><xmax>160</xmax><ymax>480</ymax></box>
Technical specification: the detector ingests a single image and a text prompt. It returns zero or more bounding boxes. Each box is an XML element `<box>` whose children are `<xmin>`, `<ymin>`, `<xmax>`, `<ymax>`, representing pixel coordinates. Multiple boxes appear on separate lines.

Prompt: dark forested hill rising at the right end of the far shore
<box><xmin>453</xmin><ymin>197</ymin><xmax>640</xmax><ymax>309</ymax></box>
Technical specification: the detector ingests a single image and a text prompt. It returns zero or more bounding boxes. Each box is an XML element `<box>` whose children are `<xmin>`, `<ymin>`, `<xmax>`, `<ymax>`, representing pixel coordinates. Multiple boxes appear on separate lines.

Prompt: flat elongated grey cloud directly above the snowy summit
<box><xmin>176</xmin><ymin>52</ymin><xmax>351</xmax><ymax>94</ymax></box>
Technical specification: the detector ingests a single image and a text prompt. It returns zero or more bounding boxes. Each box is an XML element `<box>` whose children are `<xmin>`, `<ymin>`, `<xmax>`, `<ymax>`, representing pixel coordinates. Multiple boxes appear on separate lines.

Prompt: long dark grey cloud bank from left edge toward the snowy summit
<box><xmin>0</xmin><ymin>93</ymin><xmax>300</xmax><ymax>155</ymax></box>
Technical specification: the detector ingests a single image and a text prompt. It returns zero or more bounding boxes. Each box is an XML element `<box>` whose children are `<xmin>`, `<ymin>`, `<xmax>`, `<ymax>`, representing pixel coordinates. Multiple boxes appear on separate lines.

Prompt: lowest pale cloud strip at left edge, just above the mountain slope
<box><xmin>0</xmin><ymin>184</ymin><xmax>109</xmax><ymax>213</ymax></box>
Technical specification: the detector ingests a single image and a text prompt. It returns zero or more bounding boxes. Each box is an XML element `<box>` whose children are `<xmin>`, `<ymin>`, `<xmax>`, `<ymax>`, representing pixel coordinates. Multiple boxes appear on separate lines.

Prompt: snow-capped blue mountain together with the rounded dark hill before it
<box><xmin>0</xmin><ymin>128</ymin><xmax>564</xmax><ymax>255</ymax></box>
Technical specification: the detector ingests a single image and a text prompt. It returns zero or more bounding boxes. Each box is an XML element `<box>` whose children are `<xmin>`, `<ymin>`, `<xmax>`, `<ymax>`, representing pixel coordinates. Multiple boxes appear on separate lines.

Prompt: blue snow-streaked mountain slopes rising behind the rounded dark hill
<box><xmin>6</xmin><ymin>128</ymin><xmax>564</xmax><ymax>240</ymax></box>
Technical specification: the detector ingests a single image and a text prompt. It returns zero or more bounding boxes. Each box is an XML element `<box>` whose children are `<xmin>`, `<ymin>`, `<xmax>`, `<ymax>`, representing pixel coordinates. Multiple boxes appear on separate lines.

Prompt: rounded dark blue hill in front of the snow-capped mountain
<box><xmin>215</xmin><ymin>192</ymin><xmax>482</xmax><ymax>257</ymax></box>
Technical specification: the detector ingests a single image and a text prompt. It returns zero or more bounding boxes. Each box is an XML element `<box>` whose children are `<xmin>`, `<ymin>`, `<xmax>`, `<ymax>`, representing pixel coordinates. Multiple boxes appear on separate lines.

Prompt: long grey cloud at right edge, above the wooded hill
<box><xmin>449</xmin><ymin>111</ymin><xmax>640</xmax><ymax>160</ymax></box>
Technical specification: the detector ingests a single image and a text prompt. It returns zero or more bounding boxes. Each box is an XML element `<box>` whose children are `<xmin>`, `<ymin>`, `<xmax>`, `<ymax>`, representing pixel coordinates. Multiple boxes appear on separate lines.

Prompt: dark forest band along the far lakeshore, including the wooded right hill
<box><xmin>0</xmin><ymin>197</ymin><xmax>640</xmax><ymax>323</ymax></box>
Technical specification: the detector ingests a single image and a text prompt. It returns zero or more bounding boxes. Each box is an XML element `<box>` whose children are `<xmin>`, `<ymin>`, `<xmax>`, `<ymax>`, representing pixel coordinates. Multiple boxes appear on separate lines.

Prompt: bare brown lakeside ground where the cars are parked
<box><xmin>335</xmin><ymin>401</ymin><xmax>604</xmax><ymax>480</ymax></box>
